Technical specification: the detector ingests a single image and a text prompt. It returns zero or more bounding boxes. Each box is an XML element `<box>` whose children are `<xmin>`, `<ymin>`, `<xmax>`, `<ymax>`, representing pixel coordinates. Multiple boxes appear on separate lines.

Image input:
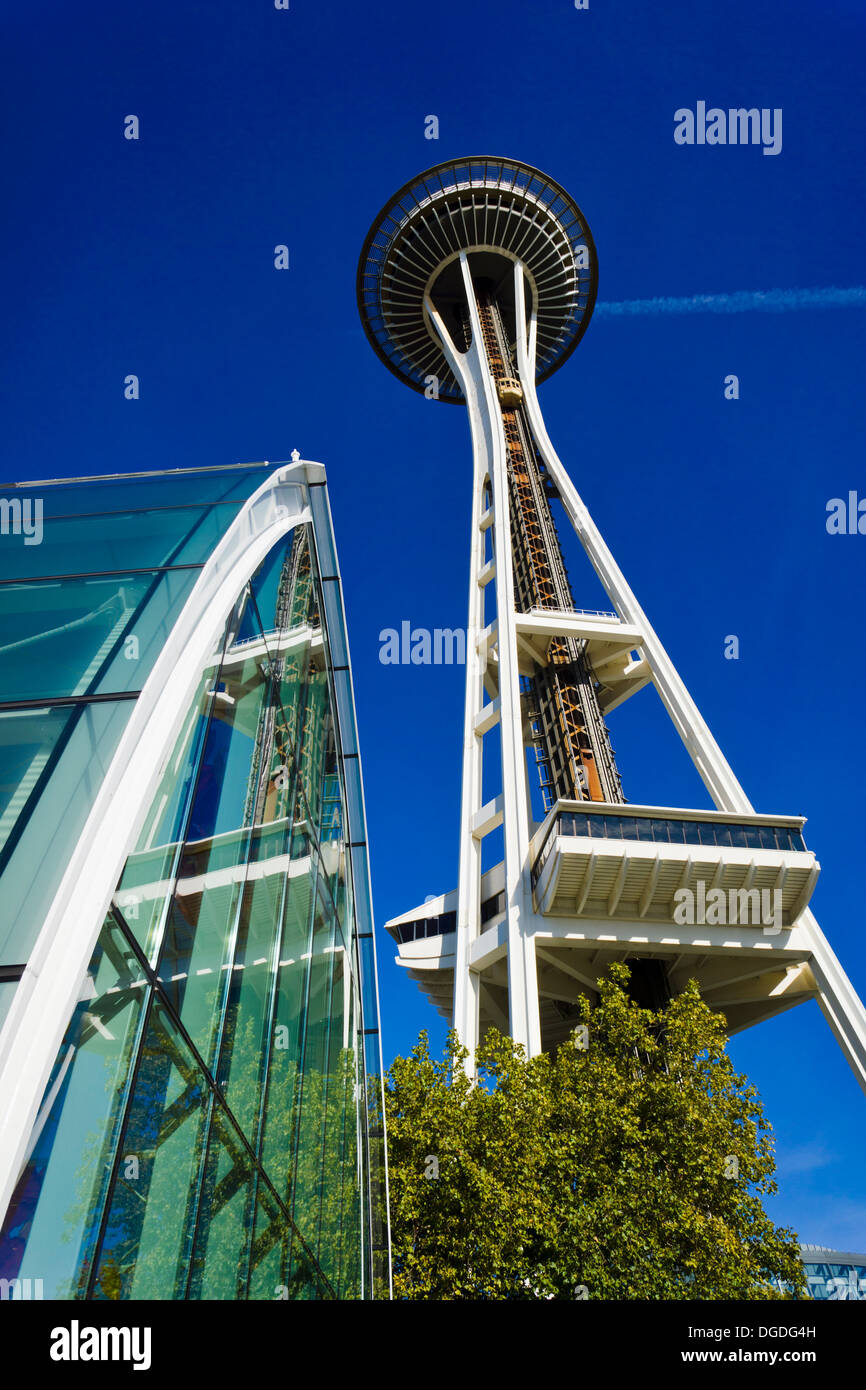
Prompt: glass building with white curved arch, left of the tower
<box><xmin>0</xmin><ymin>459</ymin><xmax>389</xmax><ymax>1300</ymax></box>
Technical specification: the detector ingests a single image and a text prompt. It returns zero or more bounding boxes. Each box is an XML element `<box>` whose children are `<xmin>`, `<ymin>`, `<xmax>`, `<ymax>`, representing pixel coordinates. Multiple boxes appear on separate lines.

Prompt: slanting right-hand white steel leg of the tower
<box><xmin>514</xmin><ymin>261</ymin><xmax>866</xmax><ymax>1091</ymax></box>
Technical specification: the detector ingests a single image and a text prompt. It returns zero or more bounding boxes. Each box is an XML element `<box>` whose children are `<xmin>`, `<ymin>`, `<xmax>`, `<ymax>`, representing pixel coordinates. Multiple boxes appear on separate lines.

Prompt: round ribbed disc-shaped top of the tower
<box><xmin>357</xmin><ymin>156</ymin><xmax>598</xmax><ymax>402</ymax></box>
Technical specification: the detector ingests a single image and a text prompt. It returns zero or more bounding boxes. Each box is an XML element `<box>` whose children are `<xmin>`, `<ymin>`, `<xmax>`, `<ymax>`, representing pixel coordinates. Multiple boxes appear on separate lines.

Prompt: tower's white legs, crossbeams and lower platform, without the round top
<box><xmin>388</xmin><ymin>252</ymin><xmax>866</xmax><ymax>1090</ymax></box>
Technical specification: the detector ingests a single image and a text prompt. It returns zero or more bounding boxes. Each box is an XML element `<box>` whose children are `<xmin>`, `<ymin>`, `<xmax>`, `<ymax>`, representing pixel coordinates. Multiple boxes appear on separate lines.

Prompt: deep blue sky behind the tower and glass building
<box><xmin>0</xmin><ymin>0</ymin><xmax>866</xmax><ymax>1250</ymax></box>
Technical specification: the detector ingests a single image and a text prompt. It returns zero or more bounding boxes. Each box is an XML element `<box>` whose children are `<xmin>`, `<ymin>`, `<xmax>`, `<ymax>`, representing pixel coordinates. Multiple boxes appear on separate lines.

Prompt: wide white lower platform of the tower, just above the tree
<box><xmin>385</xmin><ymin>801</ymin><xmax>820</xmax><ymax>1047</ymax></box>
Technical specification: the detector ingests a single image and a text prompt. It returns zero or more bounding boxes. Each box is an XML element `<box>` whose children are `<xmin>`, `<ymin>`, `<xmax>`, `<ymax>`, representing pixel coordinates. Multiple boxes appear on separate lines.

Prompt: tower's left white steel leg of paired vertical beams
<box><xmin>425</xmin><ymin>252</ymin><xmax>541</xmax><ymax>1056</ymax></box>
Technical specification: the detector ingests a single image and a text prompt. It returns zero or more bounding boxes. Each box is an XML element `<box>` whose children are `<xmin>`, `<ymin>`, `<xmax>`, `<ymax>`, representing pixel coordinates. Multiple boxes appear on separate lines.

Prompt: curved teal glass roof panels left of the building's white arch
<box><xmin>0</xmin><ymin>464</ymin><xmax>271</xmax><ymax>984</ymax></box>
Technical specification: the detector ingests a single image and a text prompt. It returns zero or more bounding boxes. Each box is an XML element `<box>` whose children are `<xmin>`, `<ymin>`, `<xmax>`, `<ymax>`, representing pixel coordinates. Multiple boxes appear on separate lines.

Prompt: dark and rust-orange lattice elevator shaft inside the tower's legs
<box><xmin>477</xmin><ymin>291</ymin><xmax>623</xmax><ymax>810</ymax></box>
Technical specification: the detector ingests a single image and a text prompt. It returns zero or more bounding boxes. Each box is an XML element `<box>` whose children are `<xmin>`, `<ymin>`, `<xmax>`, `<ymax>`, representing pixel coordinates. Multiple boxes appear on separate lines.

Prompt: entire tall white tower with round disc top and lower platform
<box><xmin>357</xmin><ymin>157</ymin><xmax>866</xmax><ymax>1090</ymax></box>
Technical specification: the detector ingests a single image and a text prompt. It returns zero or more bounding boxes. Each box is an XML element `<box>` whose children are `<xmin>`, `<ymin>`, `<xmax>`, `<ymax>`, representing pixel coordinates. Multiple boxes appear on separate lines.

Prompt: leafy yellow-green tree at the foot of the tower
<box><xmin>385</xmin><ymin>966</ymin><xmax>805</xmax><ymax>1300</ymax></box>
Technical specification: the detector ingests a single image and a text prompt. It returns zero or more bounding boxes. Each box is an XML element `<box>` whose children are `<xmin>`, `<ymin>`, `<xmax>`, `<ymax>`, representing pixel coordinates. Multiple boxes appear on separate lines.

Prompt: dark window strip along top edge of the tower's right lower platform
<box><xmin>532</xmin><ymin>810</ymin><xmax>806</xmax><ymax>887</ymax></box>
